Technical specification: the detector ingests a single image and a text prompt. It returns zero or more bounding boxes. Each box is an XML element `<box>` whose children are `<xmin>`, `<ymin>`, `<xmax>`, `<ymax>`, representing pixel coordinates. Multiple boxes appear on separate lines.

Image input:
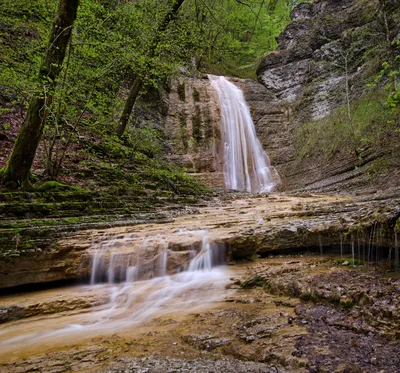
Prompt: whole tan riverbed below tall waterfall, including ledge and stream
<box><xmin>0</xmin><ymin>193</ymin><xmax>400</xmax><ymax>373</ymax></box>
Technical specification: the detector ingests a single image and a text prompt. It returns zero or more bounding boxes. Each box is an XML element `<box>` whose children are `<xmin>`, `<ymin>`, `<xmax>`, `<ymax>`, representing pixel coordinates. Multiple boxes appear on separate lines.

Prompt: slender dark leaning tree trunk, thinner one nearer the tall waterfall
<box><xmin>116</xmin><ymin>0</ymin><xmax>185</xmax><ymax>137</ymax></box>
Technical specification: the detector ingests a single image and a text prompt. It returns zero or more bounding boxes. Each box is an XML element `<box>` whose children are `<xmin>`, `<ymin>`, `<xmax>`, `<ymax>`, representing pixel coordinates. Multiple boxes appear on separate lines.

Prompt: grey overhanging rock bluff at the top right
<box><xmin>257</xmin><ymin>0</ymin><xmax>400</xmax><ymax>120</ymax></box>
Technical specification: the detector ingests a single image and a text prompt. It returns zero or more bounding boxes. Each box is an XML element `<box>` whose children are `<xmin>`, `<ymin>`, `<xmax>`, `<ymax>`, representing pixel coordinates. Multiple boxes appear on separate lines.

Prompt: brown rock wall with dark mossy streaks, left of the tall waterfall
<box><xmin>164</xmin><ymin>78</ymin><xmax>224</xmax><ymax>187</ymax></box>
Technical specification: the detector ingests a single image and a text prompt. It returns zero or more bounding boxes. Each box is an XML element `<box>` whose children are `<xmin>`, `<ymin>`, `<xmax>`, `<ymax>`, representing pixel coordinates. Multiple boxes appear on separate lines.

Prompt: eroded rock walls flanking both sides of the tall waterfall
<box><xmin>158</xmin><ymin>0</ymin><xmax>400</xmax><ymax>193</ymax></box>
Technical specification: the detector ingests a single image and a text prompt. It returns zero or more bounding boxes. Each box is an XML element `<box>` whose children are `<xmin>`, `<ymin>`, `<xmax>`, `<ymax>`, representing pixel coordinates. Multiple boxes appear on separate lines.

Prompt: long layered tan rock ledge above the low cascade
<box><xmin>0</xmin><ymin>193</ymin><xmax>400</xmax><ymax>288</ymax></box>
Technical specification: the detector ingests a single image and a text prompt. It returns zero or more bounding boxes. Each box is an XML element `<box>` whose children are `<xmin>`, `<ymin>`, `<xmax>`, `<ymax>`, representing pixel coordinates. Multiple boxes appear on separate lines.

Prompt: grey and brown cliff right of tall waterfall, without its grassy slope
<box><xmin>256</xmin><ymin>0</ymin><xmax>400</xmax><ymax>190</ymax></box>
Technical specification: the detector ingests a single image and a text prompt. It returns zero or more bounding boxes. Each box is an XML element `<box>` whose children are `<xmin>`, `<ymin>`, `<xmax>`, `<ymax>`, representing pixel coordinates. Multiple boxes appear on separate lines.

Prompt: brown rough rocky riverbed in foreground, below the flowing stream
<box><xmin>0</xmin><ymin>255</ymin><xmax>400</xmax><ymax>373</ymax></box>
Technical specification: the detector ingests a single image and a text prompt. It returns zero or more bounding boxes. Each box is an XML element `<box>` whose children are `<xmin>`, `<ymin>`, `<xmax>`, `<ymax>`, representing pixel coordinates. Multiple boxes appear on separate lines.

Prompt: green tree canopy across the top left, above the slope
<box><xmin>0</xmin><ymin>0</ymin><xmax>299</xmax><ymax>132</ymax></box>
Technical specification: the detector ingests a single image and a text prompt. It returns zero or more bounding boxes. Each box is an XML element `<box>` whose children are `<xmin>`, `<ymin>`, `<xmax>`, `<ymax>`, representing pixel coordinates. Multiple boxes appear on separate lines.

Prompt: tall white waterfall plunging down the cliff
<box><xmin>208</xmin><ymin>75</ymin><xmax>279</xmax><ymax>193</ymax></box>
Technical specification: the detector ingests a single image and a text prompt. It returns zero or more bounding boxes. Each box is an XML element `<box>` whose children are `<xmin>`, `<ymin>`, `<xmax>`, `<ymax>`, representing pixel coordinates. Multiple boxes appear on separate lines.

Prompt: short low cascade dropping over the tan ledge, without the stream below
<box><xmin>90</xmin><ymin>230</ymin><xmax>225</xmax><ymax>285</ymax></box>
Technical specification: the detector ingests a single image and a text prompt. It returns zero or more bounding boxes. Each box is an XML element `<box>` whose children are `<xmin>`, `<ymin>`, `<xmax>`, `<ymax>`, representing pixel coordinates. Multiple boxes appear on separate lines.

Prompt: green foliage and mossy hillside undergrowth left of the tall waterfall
<box><xmin>0</xmin><ymin>0</ymin><xmax>300</xmax><ymax>193</ymax></box>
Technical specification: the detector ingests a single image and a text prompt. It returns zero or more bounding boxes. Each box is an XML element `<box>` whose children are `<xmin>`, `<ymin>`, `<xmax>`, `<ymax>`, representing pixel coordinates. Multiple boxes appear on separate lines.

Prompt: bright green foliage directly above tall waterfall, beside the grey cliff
<box><xmin>180</xmin><ymin>0</ymin><xmax>303</xmax><ymax>78</ymax></box>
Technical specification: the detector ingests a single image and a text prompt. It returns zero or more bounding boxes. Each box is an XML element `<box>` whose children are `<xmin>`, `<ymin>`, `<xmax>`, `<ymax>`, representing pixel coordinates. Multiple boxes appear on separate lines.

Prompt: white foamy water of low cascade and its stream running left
<box><xmin>0</xmin><ymin>231</ymin><xmax>230</xmax><ymax>351</ymax></box>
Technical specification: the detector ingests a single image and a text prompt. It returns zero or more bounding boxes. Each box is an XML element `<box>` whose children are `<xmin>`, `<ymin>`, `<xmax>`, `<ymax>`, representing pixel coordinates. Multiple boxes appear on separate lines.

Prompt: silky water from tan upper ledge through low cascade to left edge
<box><xmin>0</xmin><ymin>195</ymin><xmax>343</xmax><ymax>358</ymax></box>
